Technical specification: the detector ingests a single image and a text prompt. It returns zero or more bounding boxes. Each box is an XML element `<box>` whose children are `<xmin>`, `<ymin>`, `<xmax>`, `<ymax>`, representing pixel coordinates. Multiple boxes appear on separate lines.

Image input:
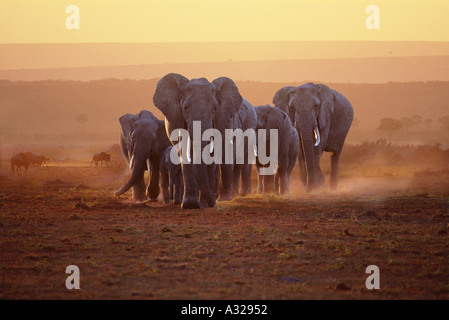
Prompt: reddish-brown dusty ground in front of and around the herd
<box><xmin>0</xmin><ymin>162</ymin><xmax>449</xmax><ymax>299</ymax></box>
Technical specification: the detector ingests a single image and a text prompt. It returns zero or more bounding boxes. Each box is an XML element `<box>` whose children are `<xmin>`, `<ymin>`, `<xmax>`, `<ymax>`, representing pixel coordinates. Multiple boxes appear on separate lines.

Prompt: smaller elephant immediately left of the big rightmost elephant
<box><xmin>255</xmin><ymin>105</ymin><xmax>299</xmax><ymax>195</ymax></box>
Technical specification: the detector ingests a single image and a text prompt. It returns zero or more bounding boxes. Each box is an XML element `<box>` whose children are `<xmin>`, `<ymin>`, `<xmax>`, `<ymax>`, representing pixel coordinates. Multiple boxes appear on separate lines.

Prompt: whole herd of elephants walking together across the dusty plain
<box><xmin>116</xmin><ymin>73</ymin><xmax>354</xmax><ymax>209</ymax></box>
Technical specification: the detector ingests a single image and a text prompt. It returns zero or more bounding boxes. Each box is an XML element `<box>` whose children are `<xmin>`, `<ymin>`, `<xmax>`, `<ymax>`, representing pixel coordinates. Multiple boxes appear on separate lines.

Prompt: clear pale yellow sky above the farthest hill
<box><xmin>0</xmin><ymin>0</ymin><xmax>449</xmax><ymax>43</ymax></box>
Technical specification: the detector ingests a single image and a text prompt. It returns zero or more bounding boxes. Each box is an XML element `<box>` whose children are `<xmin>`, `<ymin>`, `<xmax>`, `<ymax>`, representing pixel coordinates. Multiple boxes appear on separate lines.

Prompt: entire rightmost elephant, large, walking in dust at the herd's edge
<box><xmin>273</xmin><ymin>82</ymin><xmax>354</xmax><ymax>192</ymax></box>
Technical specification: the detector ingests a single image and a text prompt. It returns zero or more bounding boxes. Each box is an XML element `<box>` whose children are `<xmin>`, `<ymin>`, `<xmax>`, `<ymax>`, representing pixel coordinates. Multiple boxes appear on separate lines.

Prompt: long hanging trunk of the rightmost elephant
<box><xmin>297</xmin><ymin>121</ymin><xmax>319</xmax><ymax>192</ymax></box>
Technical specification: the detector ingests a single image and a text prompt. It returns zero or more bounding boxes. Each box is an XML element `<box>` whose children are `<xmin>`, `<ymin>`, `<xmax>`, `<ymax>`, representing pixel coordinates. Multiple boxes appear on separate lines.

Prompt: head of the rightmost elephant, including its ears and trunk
<box><xmin>273</xmin><ymin>83</ymin><xmax>335</xmax><ymax>192</ymax></box>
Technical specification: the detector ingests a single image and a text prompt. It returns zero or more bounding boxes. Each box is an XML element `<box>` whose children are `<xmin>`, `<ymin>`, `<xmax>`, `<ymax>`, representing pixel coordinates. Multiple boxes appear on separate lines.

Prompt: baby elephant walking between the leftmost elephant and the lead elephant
<box><xmin>159</xmin><ymin>146</ymin><xmax>184</xmax><ymax>205</ymax></box>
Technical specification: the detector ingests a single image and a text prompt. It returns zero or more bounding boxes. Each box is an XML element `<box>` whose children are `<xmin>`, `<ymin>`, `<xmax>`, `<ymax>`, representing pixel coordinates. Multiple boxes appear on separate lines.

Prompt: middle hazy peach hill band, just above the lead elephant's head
<box><xmin>0</xmin><ymin>56</ymin><xmax>449</xmax><ymax>83</ymax></box>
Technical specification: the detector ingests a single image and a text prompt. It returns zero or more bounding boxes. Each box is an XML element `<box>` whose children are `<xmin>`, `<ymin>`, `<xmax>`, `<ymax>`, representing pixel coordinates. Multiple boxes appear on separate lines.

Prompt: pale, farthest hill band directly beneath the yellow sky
<box><xmin>0</xmin><ymin>41</ymin><xmax>449</xmax><ymax>70</ymax></box>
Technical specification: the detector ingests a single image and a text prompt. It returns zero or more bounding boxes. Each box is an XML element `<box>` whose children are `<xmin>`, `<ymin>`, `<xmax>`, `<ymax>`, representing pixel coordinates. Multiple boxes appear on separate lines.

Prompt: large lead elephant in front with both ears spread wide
<box><xmin>153</xmin><ymin>73</ymin><xmax>244</xmax><ymax>209</ymax></box>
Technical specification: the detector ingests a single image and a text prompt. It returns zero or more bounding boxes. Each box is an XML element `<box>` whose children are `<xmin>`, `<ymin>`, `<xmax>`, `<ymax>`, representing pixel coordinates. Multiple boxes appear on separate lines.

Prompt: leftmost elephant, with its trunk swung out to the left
<box><xmin>115</xmin><ymin>110</ymin><xmax>171</xmax><ymax>201</ymax></box>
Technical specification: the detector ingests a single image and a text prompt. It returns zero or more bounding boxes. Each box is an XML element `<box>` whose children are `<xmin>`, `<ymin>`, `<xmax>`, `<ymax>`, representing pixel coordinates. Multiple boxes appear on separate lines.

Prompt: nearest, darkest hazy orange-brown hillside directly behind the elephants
<box><xmin>0</xmin><ymin>79</ymin><xmax>449</xmax><ymax>137</ymax></box>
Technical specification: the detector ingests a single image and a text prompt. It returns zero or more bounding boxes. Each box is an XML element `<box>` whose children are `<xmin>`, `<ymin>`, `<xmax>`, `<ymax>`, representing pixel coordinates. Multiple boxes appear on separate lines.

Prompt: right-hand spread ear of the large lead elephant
<box><xmin>212</xmin><ymin>77</ymin><xmax>243</xmax><ymax>119</ymax></box>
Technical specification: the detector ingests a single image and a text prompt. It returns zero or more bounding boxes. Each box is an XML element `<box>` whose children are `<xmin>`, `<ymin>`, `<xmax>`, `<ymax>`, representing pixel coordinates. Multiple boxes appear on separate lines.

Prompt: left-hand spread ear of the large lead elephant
<box><xmin>153</xmin><ymin>73</ymin><xmax>189</xmax><ymax>129</ymax></box>
